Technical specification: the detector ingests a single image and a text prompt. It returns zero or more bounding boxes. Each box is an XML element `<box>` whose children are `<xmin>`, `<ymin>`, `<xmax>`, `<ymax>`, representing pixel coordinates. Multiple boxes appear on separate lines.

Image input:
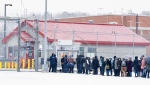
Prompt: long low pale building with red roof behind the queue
<box><xmin>2</xmin><ymin>20</ymin><xmax>150</xmax><ymax>67</ymax></box>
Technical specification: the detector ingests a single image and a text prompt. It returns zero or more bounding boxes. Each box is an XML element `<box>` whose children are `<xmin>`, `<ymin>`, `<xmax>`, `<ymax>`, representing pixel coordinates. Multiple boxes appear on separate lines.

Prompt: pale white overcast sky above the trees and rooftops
<box><xmin>0</xmin><ymin>0</ymin><xmax>150</xmax><ymax>16</ymax></box>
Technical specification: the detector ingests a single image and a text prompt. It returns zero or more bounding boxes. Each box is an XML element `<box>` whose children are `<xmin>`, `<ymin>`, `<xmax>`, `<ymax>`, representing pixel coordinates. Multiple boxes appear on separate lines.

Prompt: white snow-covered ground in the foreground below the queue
<box><xmin>0</xmin><ymin>71</ymin><xmax>150</xmax><ymax>85</ymax></box>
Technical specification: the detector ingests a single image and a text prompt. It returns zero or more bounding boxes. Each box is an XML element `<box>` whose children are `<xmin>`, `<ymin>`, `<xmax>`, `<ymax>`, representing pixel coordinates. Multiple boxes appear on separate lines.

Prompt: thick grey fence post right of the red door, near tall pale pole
<box><xmin>34</xmin><ymin>19</ymin><xmax>39</xmax><ymax>72</ymax></box>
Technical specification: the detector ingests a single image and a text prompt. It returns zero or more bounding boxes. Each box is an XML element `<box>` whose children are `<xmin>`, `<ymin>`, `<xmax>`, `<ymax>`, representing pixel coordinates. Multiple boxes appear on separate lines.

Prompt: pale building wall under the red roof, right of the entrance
<box><xmin>83</xmin><ymin>45</ymin><xmax>146</xmax><ymax>58</ymax></box>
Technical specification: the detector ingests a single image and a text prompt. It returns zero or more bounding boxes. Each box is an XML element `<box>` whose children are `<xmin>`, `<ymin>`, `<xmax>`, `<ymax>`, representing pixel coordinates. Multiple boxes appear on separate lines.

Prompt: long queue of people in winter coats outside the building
<box><xmin>49</xmin><ymin>54</ymin><xmax>150</xmax><ymax>78</ymax></box>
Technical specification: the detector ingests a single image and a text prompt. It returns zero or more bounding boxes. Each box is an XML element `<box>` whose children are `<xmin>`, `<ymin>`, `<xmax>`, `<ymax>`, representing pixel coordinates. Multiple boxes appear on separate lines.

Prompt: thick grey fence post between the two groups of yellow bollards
<box><xmin>17</xmin><ymin>20</ymin><xmax>21</xmax><ymax>72</ymax></box>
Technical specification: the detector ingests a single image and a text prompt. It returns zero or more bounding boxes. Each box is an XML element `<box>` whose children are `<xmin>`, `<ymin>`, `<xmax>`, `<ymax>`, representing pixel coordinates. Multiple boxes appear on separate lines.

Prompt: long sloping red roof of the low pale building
<box><xmin>3</xmin><ymin>20</ymin><xmax>150</xmax><ymax>46</ymax></box>
